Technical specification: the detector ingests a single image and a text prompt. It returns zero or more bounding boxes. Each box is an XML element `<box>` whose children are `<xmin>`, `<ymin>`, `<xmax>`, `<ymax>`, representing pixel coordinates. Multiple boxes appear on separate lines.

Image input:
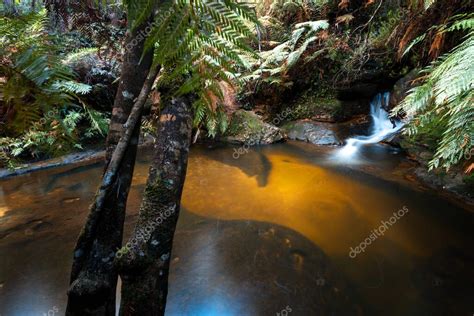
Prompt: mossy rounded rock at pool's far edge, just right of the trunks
<box><xmin>220</xmin><ymin>110</ymin><xmax>284</xmax><ymax>145</ymax></box>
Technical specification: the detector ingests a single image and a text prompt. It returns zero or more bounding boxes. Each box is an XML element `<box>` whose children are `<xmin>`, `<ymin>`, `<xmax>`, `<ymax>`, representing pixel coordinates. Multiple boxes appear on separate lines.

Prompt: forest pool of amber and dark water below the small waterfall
<box><xmin>0</xmin><ymin>142</ymin><xmax>474</xmax><ymax>316</ymax></box>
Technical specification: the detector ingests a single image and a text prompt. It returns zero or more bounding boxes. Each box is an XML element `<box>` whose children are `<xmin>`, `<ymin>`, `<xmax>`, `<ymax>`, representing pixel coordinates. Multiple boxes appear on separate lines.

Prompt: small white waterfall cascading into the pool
<box><xmin>336</xmin><ymin>92</ymin><xmax>403</xmax><ymax>159</ymax></box>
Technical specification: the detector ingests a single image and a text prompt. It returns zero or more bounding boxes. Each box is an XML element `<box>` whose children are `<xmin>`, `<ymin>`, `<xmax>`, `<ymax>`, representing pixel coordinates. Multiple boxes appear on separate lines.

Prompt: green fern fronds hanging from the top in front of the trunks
<box><xmin>126</xmin><ymin>0</ymin><xmax>258</xmax><ymax>136</ymax></box>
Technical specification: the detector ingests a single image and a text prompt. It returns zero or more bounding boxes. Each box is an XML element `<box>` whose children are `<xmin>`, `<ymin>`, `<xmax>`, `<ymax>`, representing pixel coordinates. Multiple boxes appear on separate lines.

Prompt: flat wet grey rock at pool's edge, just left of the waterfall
<box><xmin>282</xmin><ymin>120</ymin><xmax>342</xmax><ymax>145</ymax></box>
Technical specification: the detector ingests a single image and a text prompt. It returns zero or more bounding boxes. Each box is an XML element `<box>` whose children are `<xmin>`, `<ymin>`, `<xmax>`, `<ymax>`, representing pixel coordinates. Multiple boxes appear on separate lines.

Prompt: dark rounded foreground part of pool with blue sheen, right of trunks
<box><xmin>167</xmin><ymin>213</ymin><xmax>367</xmax><ymax>316</ymax></box>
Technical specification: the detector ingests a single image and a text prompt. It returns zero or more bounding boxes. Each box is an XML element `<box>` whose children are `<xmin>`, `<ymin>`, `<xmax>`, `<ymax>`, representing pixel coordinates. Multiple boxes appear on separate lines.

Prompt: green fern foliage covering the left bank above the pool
<box><xmin>0</xmin><ymin>10</ymin><xmax>107</xmax><ymax>165</ymax></box>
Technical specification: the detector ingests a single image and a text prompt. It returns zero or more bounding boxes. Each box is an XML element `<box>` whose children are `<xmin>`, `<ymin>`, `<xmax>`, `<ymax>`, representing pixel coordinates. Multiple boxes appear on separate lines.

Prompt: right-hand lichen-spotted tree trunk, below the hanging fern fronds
<box><xmin>116</xmin><ymin>98</ymin><xmax>192</xmax><ymax>316</ymax></box>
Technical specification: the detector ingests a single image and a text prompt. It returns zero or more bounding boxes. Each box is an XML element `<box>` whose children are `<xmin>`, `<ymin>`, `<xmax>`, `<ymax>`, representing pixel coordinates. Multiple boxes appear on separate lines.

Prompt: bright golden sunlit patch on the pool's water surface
<box><xmin>183</xmin><ymin>152</ymin><xmax>456</xmax><ymax>256</ymax></box>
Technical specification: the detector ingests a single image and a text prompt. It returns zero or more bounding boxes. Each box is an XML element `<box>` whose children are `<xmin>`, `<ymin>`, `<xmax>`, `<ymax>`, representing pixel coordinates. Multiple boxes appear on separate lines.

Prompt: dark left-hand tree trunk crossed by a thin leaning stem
<box><xmin>66</xmin><ymin>20</ymin><xmax>153</xmax><ymax>316</ymax></box>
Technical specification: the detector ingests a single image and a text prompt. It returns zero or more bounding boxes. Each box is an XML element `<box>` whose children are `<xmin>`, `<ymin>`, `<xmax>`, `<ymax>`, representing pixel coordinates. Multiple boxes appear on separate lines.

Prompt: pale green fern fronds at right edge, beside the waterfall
<box><xmin>394</xmin><ymin>14</ymin><xmax>474</xmax><ymax>169</ymax></box>
